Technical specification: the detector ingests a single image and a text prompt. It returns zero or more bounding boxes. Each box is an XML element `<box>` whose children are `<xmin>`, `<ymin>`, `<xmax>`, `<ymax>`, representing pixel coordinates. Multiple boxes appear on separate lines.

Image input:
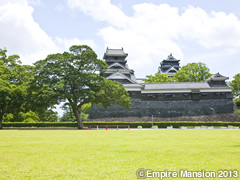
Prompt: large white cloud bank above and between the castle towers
<box><xmin>68</xmin><ymin>0</ymin><xmax>240</xmax><ymax>76</ymax></box>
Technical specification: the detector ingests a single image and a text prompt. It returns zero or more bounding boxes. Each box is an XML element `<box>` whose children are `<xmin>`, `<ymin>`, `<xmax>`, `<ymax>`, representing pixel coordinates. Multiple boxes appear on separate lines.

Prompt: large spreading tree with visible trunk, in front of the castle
<box><xmin>35</xmin><ymin>45</ymin><xmax>130</xmax><ymax>129</ymax></box>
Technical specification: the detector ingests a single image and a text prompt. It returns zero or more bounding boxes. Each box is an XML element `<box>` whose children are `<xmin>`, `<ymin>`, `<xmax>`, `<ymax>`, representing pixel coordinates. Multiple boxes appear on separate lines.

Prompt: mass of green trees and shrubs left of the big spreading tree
<box><xmin>0</xmin><ymin>49</ymin><xmax>57</xmax><ymax>128</ymax></box>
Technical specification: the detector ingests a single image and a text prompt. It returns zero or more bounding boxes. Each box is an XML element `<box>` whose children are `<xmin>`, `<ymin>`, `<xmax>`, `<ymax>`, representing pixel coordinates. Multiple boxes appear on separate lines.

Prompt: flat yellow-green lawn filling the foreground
<box><xmin>0</xmin><ymin>130</ymin><xmax>240</xmax><ymax>180</ymax></box>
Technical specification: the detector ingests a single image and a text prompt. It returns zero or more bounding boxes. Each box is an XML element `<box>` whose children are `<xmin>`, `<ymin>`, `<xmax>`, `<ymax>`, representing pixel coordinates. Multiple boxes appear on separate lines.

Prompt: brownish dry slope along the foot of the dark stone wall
<box><xmin>88</xmin><ymin>113</ymin><xmax>240</xmax><ymax>122</ymax></box>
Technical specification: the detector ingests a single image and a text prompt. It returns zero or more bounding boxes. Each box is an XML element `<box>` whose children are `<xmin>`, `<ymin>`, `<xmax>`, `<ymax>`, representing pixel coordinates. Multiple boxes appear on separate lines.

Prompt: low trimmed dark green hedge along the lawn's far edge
<box><xmin>3</xmin><ymin>121</ymin><xmax>240</xmax><ymax>128</ymax></box>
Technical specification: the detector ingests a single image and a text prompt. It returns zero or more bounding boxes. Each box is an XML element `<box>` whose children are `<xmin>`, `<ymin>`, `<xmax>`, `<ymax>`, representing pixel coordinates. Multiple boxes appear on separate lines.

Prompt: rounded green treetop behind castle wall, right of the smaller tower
<box><xmin>173</xmin><ymin>62</ymin><xmax>212</xmax><ymax>82</ymax></box>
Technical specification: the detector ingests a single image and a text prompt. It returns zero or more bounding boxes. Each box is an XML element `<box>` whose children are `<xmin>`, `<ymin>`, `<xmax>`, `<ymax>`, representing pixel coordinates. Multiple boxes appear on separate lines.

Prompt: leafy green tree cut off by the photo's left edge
<box><xmin>0</xmin><ymin>49</ymin><xmax>31</xmax><ymax>128</ymax></box>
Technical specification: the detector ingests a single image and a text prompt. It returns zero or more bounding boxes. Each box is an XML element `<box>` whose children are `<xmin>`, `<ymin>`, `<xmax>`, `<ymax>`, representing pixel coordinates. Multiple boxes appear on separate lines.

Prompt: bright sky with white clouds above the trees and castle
<box><xmin>0</xmin><ymin>0</ymin><xmax>240</xmax><ymax>114</ymax></box>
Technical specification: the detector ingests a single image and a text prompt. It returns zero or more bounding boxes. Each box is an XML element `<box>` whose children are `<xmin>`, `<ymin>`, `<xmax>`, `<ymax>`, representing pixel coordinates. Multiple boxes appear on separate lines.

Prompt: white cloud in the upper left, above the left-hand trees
<box><xmin>0</xmin><ymin>0</ymin><xmax>96</xmax><ymax>64</ymax></box>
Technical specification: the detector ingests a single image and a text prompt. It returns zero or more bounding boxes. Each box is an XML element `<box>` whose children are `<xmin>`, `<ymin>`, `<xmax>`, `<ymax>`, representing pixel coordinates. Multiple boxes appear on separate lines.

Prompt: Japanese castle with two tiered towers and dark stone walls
<box><xmin>89</xmin><ymin>48</ymin><xmax>237</xmax><ymax>122</ymax></box>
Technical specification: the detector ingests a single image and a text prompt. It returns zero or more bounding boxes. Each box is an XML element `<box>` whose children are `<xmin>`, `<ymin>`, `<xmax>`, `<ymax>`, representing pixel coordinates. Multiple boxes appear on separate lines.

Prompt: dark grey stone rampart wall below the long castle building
<box><xmin>89</xmin><ymin>98</ymin><xmax>237</xmax><ymax>121</ymax></box>
